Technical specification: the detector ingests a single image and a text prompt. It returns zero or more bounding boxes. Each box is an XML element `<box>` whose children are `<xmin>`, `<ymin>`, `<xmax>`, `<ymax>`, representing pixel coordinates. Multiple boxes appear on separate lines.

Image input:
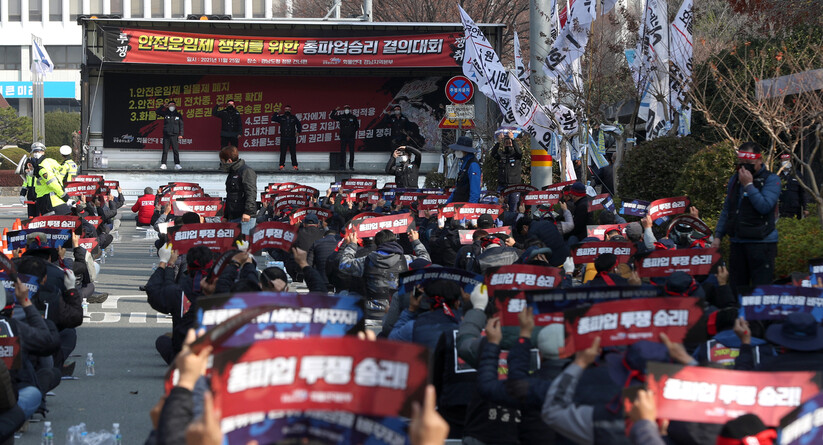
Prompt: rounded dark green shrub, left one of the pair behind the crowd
<box><xmin>618</xmin><ymin>137</ymin><xmax>702</xmax><ymax>201</ymax></box>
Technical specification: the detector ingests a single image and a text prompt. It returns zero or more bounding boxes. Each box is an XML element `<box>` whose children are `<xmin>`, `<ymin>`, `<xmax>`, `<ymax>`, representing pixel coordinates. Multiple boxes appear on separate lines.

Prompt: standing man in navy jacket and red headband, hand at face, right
<box><xmin>712</xmin><ymin>142</ymin><xmax>781</xmax><ymax>293</ymax></box>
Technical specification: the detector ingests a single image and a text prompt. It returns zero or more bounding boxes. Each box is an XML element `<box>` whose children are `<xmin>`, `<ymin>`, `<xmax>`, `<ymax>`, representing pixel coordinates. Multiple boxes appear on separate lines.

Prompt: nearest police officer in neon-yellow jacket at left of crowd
<box><xmin>28</xmin><ymin>142</ymin><xmax>69</xmax><ymax>216</ymax></box>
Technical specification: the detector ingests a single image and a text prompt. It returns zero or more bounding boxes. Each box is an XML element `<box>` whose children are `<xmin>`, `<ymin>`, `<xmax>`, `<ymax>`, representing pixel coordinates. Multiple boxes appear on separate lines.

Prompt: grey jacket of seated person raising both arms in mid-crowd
<box><xmin>340</xmin><ymin>240</ymin><xmax>431</xmax><ymax>300</ymax></box>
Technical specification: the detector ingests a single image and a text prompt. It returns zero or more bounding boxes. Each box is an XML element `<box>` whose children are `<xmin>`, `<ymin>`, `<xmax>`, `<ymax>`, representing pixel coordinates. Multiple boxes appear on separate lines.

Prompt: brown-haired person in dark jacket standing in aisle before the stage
<box><xmin>220</xmin><ymin>146</ymin><xmax>257</xmax><ymax>234</ymax></box>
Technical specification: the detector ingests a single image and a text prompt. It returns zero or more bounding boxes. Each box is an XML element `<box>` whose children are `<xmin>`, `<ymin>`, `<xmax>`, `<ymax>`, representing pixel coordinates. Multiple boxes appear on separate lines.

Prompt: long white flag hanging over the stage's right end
<box><xmin>457</xmin><ymin>5</ymin><xmax>514</xmax><ymax>123</ymax></box>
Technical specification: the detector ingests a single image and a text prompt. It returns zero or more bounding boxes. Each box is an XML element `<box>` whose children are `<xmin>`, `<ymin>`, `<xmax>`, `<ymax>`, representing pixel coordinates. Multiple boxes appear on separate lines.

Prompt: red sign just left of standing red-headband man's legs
<box><xmin>637</xmin><ymin>247</ymin><xmax>720</xmax><ymax>278</ymax></box>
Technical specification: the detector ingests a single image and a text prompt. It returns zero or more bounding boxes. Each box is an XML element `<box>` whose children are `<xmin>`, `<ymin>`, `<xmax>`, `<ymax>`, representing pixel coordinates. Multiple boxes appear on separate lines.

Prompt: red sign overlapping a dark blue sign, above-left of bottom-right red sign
<box><xmin>564</xmin><ymin>297</ymin><xmax>703</xmax><ymax>354</ymax></box>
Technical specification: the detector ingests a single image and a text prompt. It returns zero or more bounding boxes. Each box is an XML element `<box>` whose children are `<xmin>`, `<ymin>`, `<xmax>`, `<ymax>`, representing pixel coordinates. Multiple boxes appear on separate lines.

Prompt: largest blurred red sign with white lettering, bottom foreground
<box><xmin>211</xmin><ymin>337</ymin><xmax>429</xmax><ymax>425</ymax></box>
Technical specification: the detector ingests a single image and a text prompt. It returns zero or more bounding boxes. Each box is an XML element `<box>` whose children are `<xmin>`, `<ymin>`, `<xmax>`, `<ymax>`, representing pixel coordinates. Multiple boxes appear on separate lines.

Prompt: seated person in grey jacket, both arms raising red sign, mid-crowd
<box><xmin>339</xmin><ymin>230</ymin><xmax>431</xmax><ymax>318</ymax></box>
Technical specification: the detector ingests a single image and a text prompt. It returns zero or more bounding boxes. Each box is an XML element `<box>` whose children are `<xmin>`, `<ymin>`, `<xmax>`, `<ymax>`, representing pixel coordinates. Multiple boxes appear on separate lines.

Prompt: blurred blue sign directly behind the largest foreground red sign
<box><xmin>197</xmin><ymin>292</ymin><xmax>363</xmax><ymax>347</ymax></box>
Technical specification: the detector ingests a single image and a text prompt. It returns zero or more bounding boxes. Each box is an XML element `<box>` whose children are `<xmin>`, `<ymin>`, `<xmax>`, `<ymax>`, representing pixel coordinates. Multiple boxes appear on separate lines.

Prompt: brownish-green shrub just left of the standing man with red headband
<box><xmin>675</xmin><ymin>142</ymin><xmax>736</xmax><ymax>218</ymax></box>
